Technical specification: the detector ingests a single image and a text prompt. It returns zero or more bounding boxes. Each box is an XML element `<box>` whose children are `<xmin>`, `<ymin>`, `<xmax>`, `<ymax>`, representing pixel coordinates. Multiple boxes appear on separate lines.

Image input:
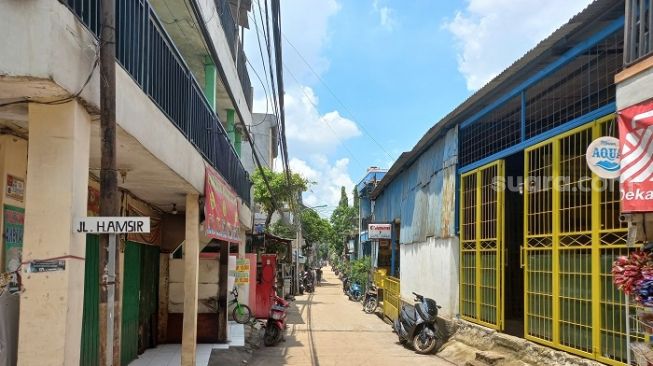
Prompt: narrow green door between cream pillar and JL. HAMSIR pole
<box><xmin>79</xmin><ymin>235</ymin><xmax>100</xmax><ymax>366</ymax></box>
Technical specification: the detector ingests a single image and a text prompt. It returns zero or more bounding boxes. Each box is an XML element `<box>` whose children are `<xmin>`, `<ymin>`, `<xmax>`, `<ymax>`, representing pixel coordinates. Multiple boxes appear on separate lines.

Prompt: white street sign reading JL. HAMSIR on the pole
<box><xmin>73</xmin><ymin>216</ymin><xmax>150</xmax><ymax>234</ymax></box>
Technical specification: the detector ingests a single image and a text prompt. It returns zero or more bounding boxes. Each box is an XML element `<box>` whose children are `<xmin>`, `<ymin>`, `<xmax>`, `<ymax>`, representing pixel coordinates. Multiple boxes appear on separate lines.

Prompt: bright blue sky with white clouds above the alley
<box><xmin>245</xmin><ymin>0</ymin><xmax>590</xmax><ymax>214</ymax></box>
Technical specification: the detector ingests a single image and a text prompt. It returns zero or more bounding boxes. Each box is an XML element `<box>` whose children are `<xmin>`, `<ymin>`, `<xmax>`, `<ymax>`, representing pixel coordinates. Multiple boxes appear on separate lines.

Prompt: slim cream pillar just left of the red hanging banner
<box><xmin>181</xmin><ymin>193</ymin><xmax>200</xmax><ymax>366</ymax></box>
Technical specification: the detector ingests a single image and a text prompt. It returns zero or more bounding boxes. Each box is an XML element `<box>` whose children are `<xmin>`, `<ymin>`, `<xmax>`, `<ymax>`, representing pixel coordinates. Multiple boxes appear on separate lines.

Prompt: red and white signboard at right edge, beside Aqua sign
<box><xmin>619</xmin><ymin>100</ymin><xmax>653</xmax><ymax>212</ymax></box>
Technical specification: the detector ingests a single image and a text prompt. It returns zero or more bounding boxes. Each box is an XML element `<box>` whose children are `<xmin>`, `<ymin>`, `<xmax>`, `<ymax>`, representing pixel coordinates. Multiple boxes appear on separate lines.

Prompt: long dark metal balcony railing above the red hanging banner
<box><xmin>62</xmin><ymin>0</ymin><xmax>251</xmax><ymax>203</ymax></box>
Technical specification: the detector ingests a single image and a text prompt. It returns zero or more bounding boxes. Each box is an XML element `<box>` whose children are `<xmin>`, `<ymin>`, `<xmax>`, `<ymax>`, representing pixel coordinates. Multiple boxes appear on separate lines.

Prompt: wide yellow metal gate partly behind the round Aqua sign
<box><xmin>522</xmin><ymin>116</ymin><xmax>627</xmax><ymax>365</ymax></box>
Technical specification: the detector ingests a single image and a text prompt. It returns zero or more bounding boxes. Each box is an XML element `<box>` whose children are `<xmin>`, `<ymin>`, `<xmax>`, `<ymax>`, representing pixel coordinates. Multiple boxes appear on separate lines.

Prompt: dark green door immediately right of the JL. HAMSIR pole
<box><xmin>120</xmin><ymin>241</ymin><xmax>141</xmax><ymax>365</ymax></box>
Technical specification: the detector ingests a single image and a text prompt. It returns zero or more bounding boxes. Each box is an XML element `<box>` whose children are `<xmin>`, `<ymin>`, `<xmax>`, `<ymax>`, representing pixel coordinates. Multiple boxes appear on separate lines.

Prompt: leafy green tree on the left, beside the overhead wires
<box><xmin>252</xmin><ymin>168</ymin><xmax>308</xmax><ymax>229</ymax></box>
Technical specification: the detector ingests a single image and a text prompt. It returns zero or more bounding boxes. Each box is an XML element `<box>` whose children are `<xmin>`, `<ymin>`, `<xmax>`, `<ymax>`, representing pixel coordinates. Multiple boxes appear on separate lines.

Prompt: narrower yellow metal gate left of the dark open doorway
<box><xmin>460</xmin><ymin>160</ymin><xmax>504</xmax><ymax>329</ymax></box>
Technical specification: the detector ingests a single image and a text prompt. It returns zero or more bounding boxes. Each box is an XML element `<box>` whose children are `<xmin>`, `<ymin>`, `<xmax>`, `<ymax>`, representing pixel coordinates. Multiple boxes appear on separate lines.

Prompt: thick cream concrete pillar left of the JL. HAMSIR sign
<box><xmin>18</xmin><ymin>101</ymin><xmax>91</xmax><ymax>366</ymax></box>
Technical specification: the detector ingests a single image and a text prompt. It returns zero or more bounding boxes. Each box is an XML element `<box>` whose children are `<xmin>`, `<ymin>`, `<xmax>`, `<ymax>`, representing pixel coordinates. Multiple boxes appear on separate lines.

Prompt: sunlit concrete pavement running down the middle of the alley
<box><xmin>244</xmin><ymin>267</ymin><xmax>454</xmax><ymax>366</ymax></box>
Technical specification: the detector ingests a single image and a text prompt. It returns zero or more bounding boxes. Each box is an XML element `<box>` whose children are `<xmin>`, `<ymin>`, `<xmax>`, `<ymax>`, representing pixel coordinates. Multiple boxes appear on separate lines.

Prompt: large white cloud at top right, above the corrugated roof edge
<box><xmin>444</xmin><ymin>0</ymin><xmax>592</xmax><ymax>90</ymax></box>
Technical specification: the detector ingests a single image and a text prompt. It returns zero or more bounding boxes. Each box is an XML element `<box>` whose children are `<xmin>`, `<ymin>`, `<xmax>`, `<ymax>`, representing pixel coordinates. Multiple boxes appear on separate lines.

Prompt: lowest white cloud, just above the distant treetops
<box><xmin>289</xmin><ymin>156</ymin><xmax>354</xmax><ymax>217</ymax></box>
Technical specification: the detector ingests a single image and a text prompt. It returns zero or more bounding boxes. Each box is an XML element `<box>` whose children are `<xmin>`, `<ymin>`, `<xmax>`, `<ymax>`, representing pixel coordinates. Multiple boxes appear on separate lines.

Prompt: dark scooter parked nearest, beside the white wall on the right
<box><xmin>393</xmin><ymin>292</ymin><xmax>444</xmax><ymax>354</ymax></box>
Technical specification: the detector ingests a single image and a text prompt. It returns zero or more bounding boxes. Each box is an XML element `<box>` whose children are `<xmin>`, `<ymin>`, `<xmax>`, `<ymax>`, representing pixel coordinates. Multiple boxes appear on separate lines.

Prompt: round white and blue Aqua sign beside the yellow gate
<box><xmin>585</xmin><ymin>136</ymin><xmax>620</xmax><ymax>179</ymax></box>
